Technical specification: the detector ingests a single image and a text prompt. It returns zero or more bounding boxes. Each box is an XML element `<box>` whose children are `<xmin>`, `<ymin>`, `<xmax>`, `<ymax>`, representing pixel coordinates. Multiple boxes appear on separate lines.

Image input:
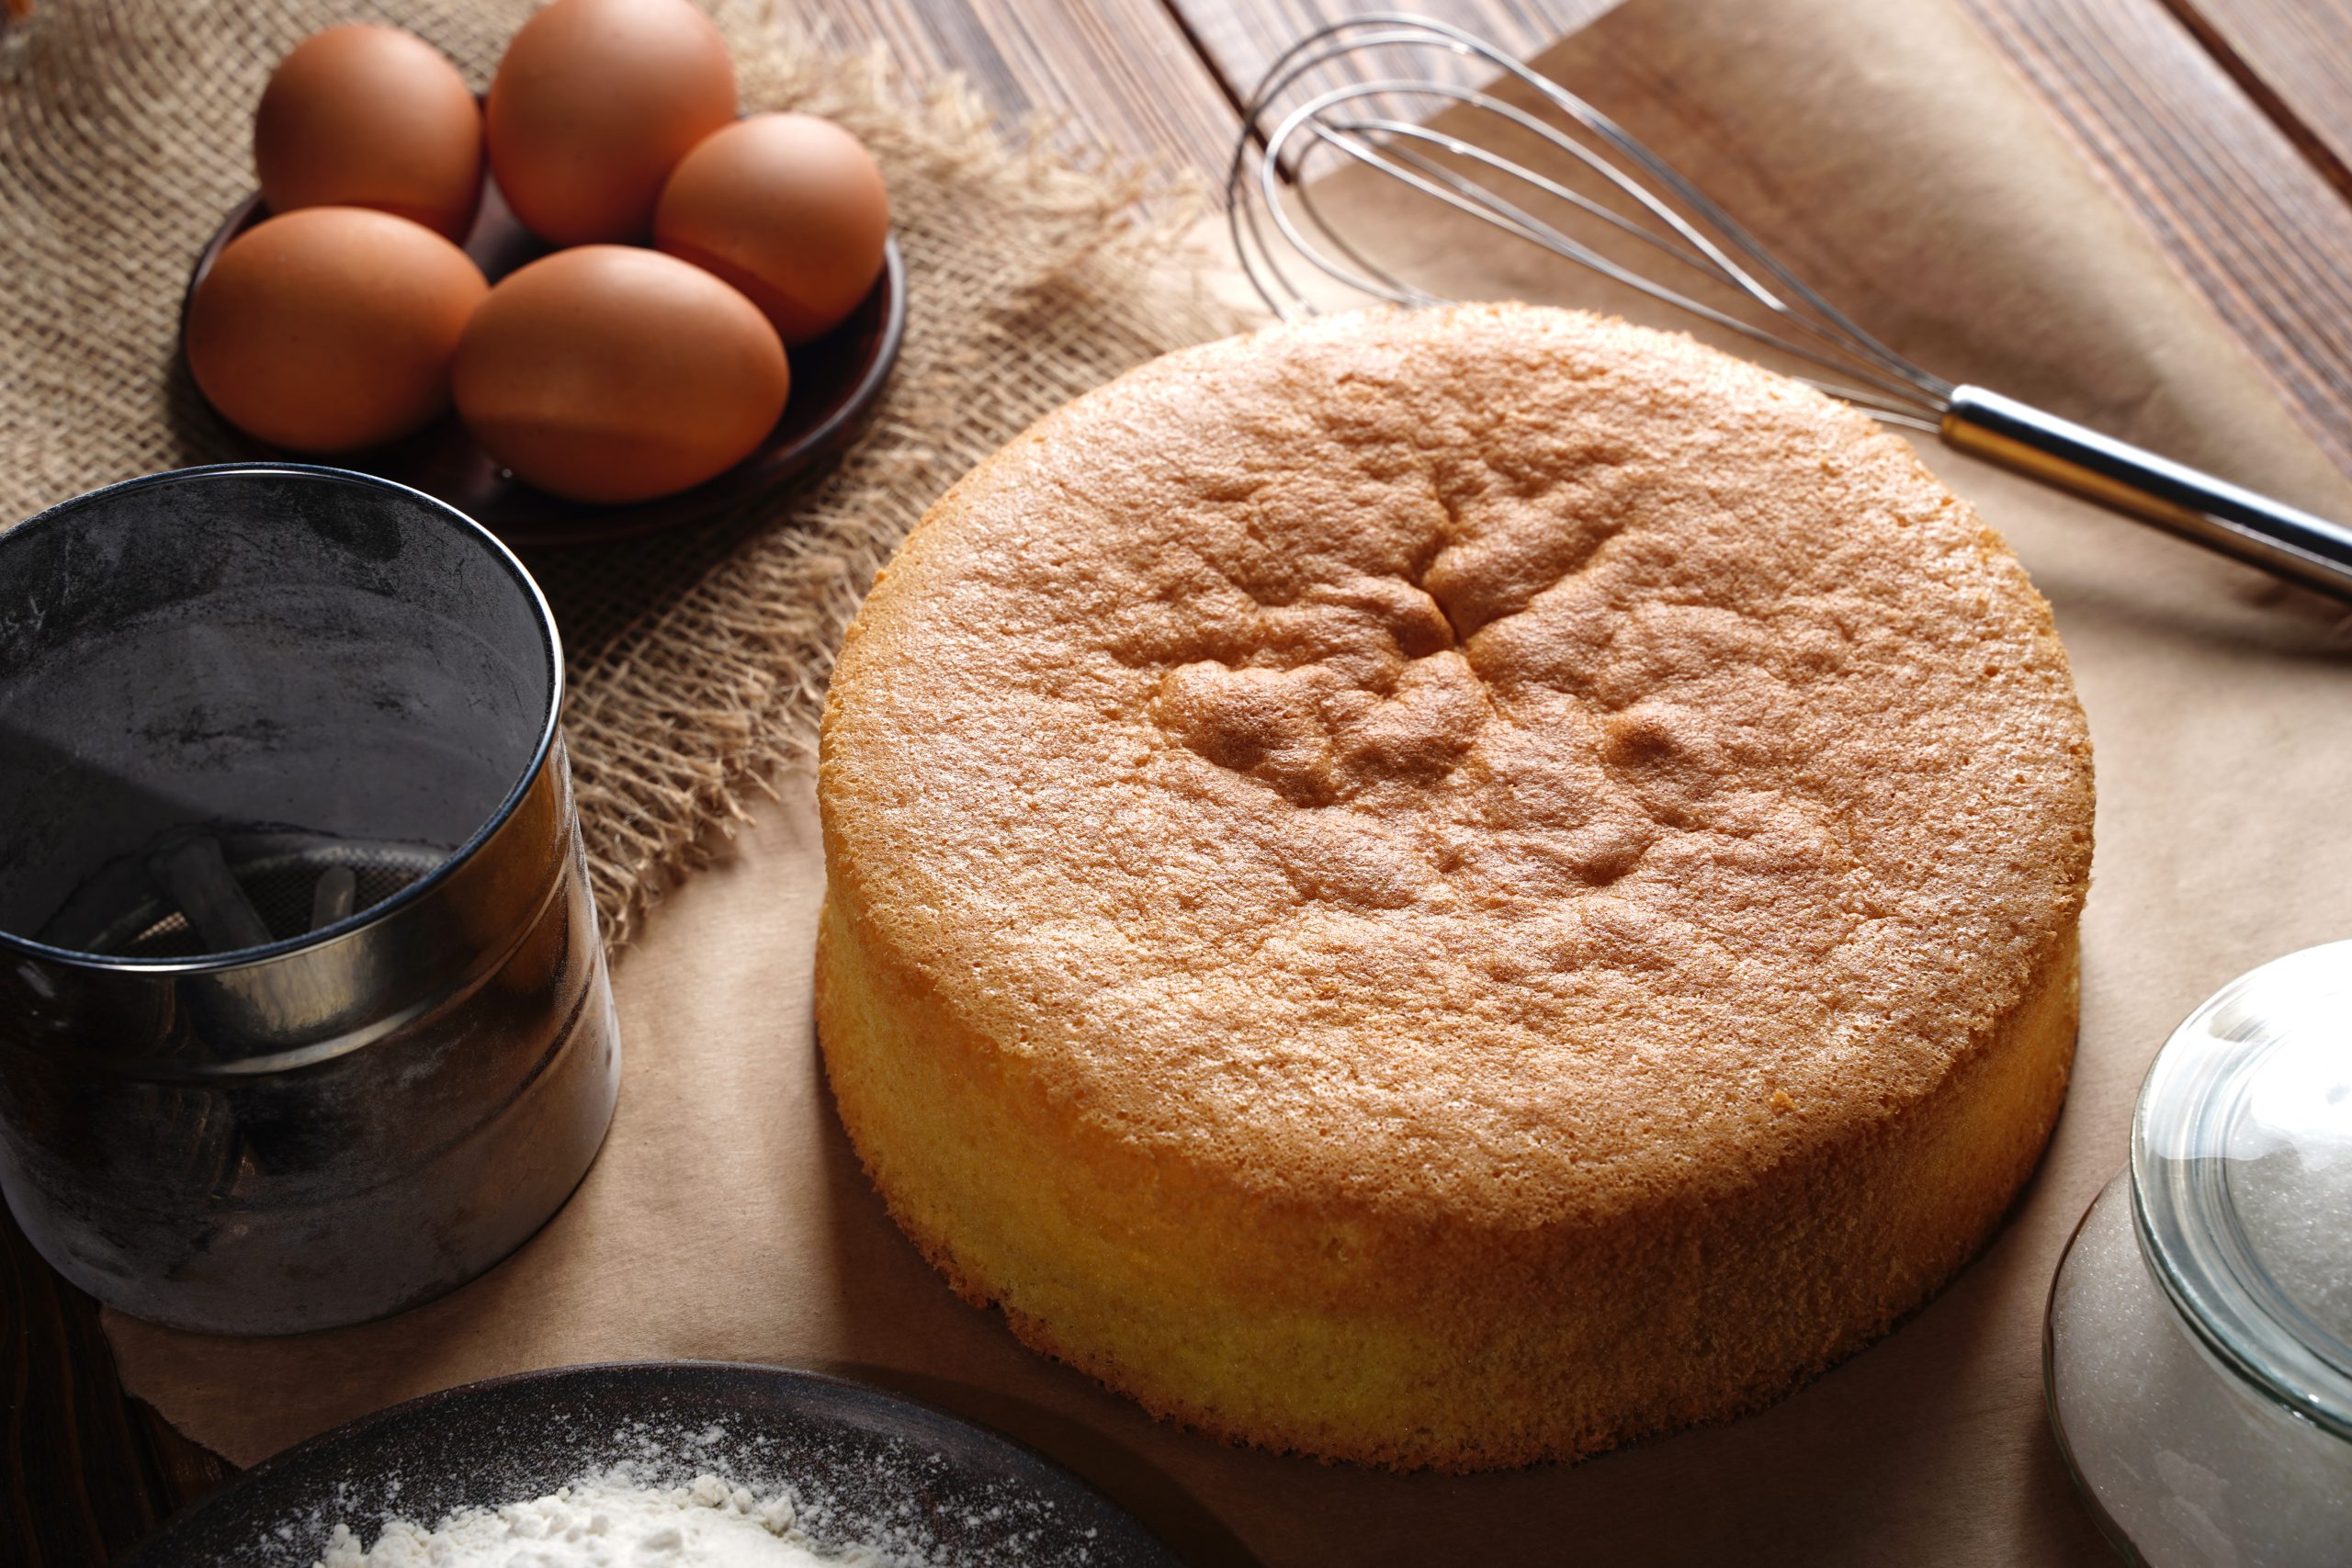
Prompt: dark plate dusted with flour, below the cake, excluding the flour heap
<box><xmin>125</xmin><ymin>1361</ymin><xmax>1181</xmax><ymax>1568</ymax></box>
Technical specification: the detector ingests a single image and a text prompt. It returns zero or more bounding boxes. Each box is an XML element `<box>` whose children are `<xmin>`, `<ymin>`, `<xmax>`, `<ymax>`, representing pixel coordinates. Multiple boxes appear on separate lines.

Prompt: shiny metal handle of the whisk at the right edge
<box><xmin>1940</xmin><ymin>386</ymin><xmax>2352</xmax><ymax>602</ymax></box>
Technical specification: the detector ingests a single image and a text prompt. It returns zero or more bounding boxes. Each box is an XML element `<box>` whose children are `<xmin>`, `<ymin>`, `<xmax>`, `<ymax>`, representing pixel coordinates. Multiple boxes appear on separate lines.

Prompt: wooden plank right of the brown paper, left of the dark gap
<box><xmin>1962</xmin><ymin>0</ymin><xmax>2352</xmax><ymax>470</ymax></box>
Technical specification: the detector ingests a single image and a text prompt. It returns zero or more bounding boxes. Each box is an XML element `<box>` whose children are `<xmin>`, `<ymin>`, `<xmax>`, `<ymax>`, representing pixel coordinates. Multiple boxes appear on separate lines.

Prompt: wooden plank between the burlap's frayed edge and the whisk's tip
<box><xmin>797</xmin><ymin>0</ymin><xmax>1238</xmax><ymax>176</ymax></box>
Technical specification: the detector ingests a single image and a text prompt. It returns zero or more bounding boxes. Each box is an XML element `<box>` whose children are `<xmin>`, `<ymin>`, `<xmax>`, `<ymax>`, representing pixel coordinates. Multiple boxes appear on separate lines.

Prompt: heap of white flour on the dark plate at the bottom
<box><xmin>318</xmin><ymin>1470</ymin><xmax>877</xmax><ymax>1568</ymax></box>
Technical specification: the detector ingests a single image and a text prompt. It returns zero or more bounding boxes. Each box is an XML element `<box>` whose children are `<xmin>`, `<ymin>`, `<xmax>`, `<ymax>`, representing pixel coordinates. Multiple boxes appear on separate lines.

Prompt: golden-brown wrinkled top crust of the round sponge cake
<box><xmin>826</xmin><ymin>308</ymin><xmax>2091</xmax><ymax>1223</ymax></box>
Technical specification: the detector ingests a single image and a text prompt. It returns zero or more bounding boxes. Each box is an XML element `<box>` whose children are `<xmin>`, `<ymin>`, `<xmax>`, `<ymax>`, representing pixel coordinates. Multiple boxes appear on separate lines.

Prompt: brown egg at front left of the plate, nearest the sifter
<box><xmin>186</xmin><ymin>207</ymin><xmax>489</xmax><ymax>451</ymax></box>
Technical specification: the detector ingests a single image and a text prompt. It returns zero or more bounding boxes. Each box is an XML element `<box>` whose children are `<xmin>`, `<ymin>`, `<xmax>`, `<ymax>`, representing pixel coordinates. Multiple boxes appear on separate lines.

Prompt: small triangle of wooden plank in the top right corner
<box><xmin>2164</xmin><ymin>0</ymin><xmax>2352</xmax><ymax>202</ymax></box>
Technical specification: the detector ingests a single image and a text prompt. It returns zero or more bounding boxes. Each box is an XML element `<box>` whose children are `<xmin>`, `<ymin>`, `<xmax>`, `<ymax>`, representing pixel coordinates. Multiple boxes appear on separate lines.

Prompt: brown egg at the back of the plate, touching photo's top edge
<box><xmin>489</xmin><ymin>0</ymin><xmax>734</xmax><ymax>244</ymax></box>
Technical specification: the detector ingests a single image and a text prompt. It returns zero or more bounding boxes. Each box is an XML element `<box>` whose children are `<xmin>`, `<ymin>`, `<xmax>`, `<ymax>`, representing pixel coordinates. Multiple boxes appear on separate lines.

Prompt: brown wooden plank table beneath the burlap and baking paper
<box><xmin>0</xmin><ymin>0</ymin><xmax>2352</xmax><ymax>1568</ymax></box>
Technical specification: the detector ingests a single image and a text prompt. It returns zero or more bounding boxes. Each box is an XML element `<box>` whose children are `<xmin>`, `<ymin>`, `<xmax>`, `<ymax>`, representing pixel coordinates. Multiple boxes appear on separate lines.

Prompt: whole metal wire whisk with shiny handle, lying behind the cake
<box><xmin>1226</xmin><ymin>12</ymin><xmax>2352</xmax><ymax>600</ymax></box>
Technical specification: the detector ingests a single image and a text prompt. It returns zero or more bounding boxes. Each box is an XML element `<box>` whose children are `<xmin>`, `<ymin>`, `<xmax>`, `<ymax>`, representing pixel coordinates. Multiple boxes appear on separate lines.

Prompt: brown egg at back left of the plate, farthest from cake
<box><xmin>254</xmin><ymin>26</ymin><xmax>482</xmax><ymax>240</ymax></box>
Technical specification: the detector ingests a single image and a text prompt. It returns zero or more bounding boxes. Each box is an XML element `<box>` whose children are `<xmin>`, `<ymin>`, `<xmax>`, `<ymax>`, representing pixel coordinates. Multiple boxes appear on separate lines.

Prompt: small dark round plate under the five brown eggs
<box><xmin>181</xmin><ymin>176</ymin><xmax>906</xmax><ymax>546</ymax></box>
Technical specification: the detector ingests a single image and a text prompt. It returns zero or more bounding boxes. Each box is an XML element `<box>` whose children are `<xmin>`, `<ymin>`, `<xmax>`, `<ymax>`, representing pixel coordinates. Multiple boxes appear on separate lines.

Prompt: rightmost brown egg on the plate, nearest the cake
<box><xmin>654</xmin><ymin>115</ymin><xmax>889</xmax><ymax>344</ymax></box>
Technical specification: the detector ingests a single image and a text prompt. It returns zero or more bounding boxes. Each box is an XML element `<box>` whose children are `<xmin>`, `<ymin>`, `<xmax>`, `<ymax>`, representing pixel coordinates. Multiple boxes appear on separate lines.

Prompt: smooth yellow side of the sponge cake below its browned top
<box><xmin>816</xmin><ymin>884</ymin><xmax>2076</xmax><ymax>1470</ymax></box>
